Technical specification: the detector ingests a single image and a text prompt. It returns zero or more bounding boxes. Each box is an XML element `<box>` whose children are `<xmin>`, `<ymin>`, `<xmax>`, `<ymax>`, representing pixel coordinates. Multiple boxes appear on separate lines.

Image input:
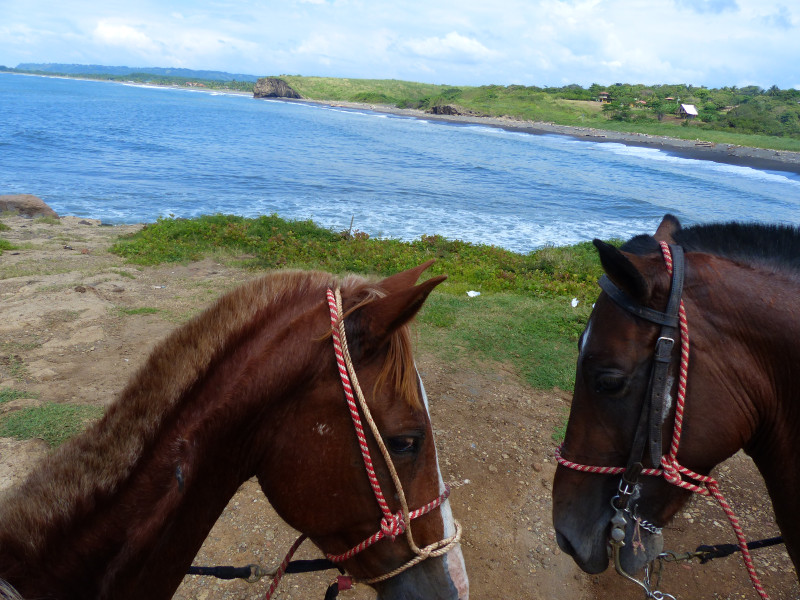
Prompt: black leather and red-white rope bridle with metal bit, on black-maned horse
<box><xmin>556</xmin><ymin>241</ymin><xmax>769</xmax><ymax>600</ymax></box>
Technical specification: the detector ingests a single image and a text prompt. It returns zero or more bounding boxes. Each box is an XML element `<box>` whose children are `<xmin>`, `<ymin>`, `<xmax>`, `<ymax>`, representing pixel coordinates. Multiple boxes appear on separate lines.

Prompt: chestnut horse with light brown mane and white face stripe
<box><xmin>0</xmin><ymin>263</ymin><xmax>468</xmax><ymax>600</ymax></box>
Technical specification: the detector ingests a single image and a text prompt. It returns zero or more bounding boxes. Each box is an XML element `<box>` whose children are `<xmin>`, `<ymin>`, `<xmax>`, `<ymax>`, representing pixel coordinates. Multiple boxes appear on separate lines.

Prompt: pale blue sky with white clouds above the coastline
<box><xmin>0</xmin><ymin>0</ymin><xmax>800</xmax><ymax>89</ymax></box>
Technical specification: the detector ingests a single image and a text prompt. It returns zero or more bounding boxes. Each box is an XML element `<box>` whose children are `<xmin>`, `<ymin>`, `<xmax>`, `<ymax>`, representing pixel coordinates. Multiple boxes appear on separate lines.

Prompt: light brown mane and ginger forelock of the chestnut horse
<box><xmin>0</xmin><ymin>271</ymin><xmax>418</xmax><ymax>560</ymax></box>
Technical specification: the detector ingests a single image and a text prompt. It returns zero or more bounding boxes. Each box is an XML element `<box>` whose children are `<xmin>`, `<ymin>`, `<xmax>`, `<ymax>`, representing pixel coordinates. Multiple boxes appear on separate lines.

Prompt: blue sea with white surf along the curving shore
<box><xmin>0</xmin><ymin>73</ymin><xmax>800</xmax><ymax>252</ymax></box>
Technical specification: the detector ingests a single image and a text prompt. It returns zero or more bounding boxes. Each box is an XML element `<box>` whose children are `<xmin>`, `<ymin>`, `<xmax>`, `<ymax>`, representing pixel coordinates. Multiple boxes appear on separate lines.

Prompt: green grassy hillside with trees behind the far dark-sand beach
<box><xmin>281</xmin><ymin>75</ymin><xmax>800</xmax><ymax>151</ymax></box>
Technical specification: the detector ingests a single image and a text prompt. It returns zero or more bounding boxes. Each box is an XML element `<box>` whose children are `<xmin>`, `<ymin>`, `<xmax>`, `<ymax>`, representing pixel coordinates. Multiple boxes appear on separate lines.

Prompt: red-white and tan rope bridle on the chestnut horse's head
<box><xmin>266</xmin><ymin>288</ymin><xmax>461</xmax><ymax>600</ymax></box>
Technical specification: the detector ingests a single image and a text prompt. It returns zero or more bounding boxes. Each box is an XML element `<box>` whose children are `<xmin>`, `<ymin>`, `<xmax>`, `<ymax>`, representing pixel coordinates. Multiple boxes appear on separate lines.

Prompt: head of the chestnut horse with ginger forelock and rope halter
<box><xmin>258</xmin><ymin>263</ymin><xmax>468</xmax><ymax>599</ymax></box>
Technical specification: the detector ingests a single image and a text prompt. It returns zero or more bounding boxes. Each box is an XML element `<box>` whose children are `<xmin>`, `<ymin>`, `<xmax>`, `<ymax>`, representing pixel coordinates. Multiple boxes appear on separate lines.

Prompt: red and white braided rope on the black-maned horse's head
<box><xmin>556</xmin><ymin>241</ymin><xmax>769</xmax><ymax>600</ymax></box>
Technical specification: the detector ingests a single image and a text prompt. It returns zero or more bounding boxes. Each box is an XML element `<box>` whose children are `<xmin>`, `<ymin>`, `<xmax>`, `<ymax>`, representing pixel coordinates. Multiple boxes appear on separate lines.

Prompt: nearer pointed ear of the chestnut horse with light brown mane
<box><xmin>358</xmin><ymin>274</ymin><xmax>447</xmax><ymax>345</ymax></box>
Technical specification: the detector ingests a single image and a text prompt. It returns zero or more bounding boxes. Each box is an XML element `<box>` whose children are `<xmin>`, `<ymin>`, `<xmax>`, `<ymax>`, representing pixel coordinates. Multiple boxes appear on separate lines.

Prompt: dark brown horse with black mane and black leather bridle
<box><xmin>553</xmin><ymin>215</ymin><xmax>800</xmax><ymax>596</ymax></box>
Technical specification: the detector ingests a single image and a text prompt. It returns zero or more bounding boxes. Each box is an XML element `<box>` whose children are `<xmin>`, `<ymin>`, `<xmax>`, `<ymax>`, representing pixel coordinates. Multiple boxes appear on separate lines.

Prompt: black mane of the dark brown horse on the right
<box><xmin>622</xmin><ymin>222</ymin><xmax>800</xmax><ymax>273</ymax></box>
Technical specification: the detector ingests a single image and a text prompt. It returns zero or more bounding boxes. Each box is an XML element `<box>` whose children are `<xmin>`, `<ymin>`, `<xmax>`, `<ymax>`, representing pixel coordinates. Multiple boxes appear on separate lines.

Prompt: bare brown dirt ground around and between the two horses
<box><xmin>0</xmin><ymin>217</ymin><xmax>800</xmax><ymax>600</ymax></box>
